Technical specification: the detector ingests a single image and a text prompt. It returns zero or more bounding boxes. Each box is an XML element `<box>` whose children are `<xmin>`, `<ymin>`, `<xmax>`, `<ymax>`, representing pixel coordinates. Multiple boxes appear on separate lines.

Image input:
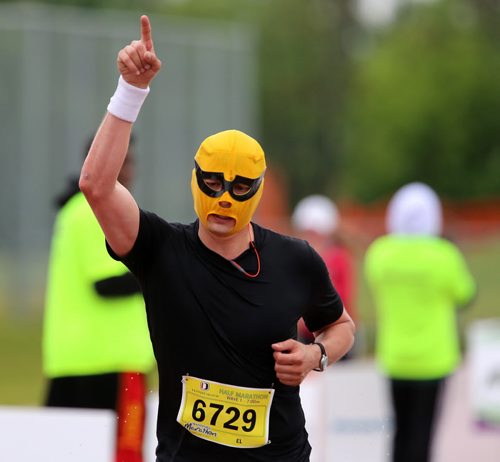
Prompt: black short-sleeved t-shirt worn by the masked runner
<box><xmin>110</xmin><ymin>210</ymin><xmax>343</xmax><ymax>462</ymax></box>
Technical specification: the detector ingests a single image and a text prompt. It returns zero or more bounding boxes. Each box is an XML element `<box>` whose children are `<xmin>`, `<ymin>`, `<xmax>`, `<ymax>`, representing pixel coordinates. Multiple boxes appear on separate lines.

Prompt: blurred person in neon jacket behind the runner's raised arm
<box><xmin>42</xmin><ymin>134</ymin><xmax>154</xmax><ymax>462</ymax></box>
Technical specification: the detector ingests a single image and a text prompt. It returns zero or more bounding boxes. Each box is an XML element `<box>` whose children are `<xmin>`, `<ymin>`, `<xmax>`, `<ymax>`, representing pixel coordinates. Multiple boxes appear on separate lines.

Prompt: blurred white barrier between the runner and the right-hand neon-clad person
<box><xmin>301</xmin><ymin>361</ymin><xmax>392</xmax><ymax>462</ymax></box>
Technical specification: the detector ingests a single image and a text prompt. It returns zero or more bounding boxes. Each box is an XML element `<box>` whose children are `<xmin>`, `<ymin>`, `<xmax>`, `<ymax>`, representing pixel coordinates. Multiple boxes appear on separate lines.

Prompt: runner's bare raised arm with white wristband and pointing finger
<box><xmin>79</xmin><ymin>16</ymin><xmax>161</xmax><ymax>256</ymax></box>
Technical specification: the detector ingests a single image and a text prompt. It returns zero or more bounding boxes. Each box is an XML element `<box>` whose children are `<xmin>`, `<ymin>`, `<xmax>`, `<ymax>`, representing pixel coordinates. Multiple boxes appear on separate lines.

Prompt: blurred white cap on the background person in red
<box><xmin>292</xmin><ymin>194</ymin><xmax>339</xmax><ymax>235</ymax></box>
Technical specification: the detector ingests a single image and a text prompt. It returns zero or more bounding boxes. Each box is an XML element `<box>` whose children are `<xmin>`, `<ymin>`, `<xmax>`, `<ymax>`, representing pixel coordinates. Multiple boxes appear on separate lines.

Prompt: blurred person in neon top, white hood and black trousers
<box><xmin>365</xmin><ymin>182</ymin><xmax>476</xmax><ymax>462</ymax></box>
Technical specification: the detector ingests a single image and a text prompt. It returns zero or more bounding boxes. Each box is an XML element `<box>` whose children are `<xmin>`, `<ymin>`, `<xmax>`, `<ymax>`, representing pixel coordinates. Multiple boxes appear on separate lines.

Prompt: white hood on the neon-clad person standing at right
<box><xmin>386</xmin><ymin>182</ymin><xmax>443</xmax><ymax>236</ymax></box>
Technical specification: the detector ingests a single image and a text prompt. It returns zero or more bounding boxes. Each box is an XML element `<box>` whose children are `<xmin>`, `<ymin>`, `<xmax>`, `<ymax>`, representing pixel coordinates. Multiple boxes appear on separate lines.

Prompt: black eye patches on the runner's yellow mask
<box><xmin>194</xmin><ymin>161</ymin><xmax>264</xmax><ymax>202</ymax></box>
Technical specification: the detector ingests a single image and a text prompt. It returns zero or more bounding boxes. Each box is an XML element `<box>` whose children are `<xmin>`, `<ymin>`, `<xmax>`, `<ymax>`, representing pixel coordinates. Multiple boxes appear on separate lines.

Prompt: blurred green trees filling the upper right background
<box><xmin>23</xmin><ymin>0</ymin><xmax>500</xmax><ymax>203</ymax></box>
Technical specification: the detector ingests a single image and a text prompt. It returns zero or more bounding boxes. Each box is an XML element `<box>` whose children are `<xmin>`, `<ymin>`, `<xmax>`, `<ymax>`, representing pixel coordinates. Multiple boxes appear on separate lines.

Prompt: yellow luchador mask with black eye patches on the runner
<box><xmin>191</xmin><ymin>130</ymin><xmax>266</xmax><ymax>234</ymax></box>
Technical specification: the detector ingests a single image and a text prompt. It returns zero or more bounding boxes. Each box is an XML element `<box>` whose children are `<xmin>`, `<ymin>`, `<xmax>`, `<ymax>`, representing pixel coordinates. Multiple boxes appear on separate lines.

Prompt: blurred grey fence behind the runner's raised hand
<box><xmin>0</xmin><ymin>3</ymin><xmax>258</xmax><ymax>313</ymax></box>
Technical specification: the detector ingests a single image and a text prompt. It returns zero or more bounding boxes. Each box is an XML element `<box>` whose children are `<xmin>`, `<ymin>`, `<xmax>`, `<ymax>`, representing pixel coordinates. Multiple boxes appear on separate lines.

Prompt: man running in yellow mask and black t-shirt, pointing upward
<box><xmin>80</xmin><ymin>16</ymin><xmax>354</xmax><ymax>462</ymax></box>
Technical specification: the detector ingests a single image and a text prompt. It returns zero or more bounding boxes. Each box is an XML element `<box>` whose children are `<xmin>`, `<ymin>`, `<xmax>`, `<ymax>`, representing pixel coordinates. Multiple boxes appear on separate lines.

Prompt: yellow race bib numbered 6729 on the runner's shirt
<box><xmin>177</xmin><ymin>375</ymin><xmax>274</xmax><ymax>448</ymax></box>
